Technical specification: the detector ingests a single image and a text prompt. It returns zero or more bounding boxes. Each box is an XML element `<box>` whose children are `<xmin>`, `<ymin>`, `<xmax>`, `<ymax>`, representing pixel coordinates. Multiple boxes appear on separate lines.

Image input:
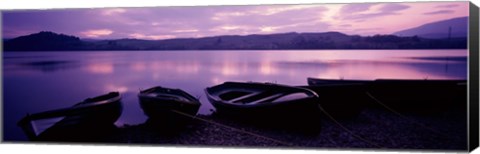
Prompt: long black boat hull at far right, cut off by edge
<box><xmin>307</xmin><ymin>78</ymin><xmax>467</xmax><ymax>113</ymax></box>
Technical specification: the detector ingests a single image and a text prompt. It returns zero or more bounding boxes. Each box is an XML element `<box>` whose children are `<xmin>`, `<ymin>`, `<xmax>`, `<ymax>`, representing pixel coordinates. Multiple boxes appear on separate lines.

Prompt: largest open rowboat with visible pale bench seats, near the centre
<box><xmin>205</xmin><ymin>82</ymin><xmax>320</xmax><ymax>129</ymax></box>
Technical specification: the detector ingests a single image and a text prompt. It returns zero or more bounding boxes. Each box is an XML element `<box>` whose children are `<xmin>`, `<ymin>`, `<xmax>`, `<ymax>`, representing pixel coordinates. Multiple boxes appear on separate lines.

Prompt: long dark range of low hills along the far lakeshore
<box><xmin>4</xmin><ymin>32</ymin><xmax>467</xmax><ymax>51</ymax></box>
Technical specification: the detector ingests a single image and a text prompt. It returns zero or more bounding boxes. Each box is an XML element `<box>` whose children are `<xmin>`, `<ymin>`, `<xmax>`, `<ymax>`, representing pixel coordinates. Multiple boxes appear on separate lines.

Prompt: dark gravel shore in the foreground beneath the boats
<box><xmin>84</xmin><ymin>103</ymin><xmax>467</xmax><ymax>151</ymax></box>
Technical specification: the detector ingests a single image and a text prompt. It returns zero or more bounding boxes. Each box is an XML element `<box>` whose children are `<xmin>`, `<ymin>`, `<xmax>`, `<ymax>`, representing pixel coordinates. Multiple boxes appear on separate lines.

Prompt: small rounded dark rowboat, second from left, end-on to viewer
<box><xmin>138</xmin><ymin>86</ymin><xmax>201</xmax><ymax>123</ymax></box>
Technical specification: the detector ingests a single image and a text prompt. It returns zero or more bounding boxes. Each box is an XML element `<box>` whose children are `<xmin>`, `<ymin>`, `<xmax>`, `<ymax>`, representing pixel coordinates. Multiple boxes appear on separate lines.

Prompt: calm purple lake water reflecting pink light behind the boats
<box><xmin>3</xmin><ymin>50</ymin><xmax>468</xmax><ymax>141</ymax></box>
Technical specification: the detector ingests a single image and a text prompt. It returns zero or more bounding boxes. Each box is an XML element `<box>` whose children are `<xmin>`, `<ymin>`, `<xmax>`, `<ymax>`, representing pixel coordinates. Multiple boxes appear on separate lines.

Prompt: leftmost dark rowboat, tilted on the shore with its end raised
<box><xmin>18</xmin><ymin>92</ymin><xmax>122</xmax><ymax>141</ymax></box>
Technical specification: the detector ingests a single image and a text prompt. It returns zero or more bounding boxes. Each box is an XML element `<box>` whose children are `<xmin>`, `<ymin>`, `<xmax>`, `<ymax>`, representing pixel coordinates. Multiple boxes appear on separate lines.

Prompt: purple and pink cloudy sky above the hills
<box><xmin>2</xmin><ymin>2</ymin><xmax>468</xmax><ymax>39</ymax></box>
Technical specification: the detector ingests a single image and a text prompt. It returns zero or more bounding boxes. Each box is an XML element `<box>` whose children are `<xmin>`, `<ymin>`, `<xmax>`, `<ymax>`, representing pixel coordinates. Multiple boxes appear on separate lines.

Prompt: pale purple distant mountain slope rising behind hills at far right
<box><xmin>393</xmin><ymin>17</ymin><xmax>468</xmax><ymax>38</ymax></box>
